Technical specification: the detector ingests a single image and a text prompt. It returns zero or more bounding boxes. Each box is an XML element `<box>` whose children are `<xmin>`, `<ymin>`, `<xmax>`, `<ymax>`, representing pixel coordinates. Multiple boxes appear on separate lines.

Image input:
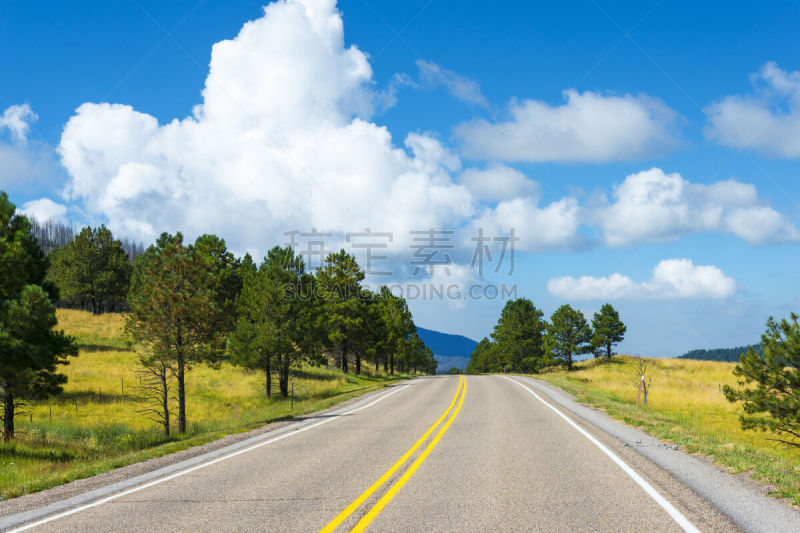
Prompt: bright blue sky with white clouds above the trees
<box><xmin>0</xmin><ymin>0</ymin><xmax>800</xmax><ymax>356</ymax></box>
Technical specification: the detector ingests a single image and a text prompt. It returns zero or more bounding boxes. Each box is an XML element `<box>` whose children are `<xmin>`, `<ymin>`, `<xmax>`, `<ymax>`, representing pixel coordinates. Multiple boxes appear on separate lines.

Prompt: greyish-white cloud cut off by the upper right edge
<box><xmin>705</xmin><ymin>62</ymin><xmax>800</xmax><ymax>157</ymax></box>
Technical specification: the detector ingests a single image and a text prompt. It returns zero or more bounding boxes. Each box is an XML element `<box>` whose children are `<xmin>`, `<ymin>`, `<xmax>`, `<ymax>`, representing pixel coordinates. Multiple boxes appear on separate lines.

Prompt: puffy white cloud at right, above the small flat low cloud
<box><xmin>592</xmin><ymin>168</ymin><xmax>800</xmax><ymax>246</ymax></box>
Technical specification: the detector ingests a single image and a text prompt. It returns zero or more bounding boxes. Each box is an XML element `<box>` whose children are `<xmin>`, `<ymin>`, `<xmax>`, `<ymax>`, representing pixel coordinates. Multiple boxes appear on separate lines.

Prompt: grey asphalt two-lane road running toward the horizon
<box><xmin>6</xmin><ymin>376</ymin><xmax>752</xmax><ymax>532</ymax></box>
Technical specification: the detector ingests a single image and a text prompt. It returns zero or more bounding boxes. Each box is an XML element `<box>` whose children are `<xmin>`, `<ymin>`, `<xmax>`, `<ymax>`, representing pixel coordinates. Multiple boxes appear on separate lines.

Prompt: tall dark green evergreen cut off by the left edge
<box><xmin>0</xmin><ymin>191</ymin><xmax>77</xmax><ymax>441</ymax></box>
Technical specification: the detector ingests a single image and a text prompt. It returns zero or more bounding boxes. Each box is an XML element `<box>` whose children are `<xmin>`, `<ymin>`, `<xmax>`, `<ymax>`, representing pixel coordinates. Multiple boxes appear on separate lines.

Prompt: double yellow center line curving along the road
<box><xmin>320</xmin><ymin>376</ymin><xmax>467</xmax><ymax>533</ymax></box>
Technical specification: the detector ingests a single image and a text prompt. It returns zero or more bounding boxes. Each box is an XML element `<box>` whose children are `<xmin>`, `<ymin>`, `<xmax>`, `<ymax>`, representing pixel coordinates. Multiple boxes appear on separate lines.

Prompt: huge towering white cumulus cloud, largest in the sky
<box><xmin>59</xmin><ymin>0</ymin><xmax>482</xmax><ymax>250</ymax></box>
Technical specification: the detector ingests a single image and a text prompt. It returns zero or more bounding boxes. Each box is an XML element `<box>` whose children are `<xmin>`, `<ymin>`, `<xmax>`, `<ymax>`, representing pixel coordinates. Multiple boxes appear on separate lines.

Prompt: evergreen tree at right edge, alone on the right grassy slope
<box><xmin>725</xmin><ymin>313</ymin><xmax>800</xmax><ymax>447</ymax></box>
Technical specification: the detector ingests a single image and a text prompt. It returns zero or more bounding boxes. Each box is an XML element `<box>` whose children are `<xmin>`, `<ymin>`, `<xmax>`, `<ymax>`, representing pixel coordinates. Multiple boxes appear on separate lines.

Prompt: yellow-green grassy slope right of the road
<box><xmin>537</xmin><ymin>357</ymin><xmax>800</xmax><ymax>505</ymax></box>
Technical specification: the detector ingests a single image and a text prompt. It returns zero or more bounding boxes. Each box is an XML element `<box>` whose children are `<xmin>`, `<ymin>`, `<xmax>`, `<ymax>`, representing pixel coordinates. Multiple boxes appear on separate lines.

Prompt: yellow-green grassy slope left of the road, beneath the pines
<box><xmin>0</xmin><ymin>310</ymin><xmax>410</xmax><ymax>498</ymax></box>
